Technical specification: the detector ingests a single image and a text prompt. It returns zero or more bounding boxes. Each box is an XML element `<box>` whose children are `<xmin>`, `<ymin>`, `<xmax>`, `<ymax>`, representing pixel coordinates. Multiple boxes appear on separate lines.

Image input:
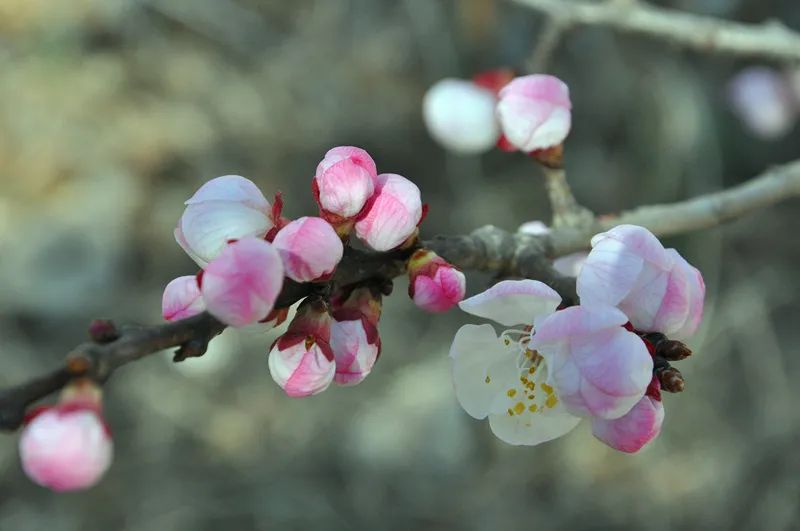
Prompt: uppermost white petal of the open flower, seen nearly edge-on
<box><xmin>459</xmin><ymin>280</ymin><xmax>561</xmax><ymax>326</ymax></box>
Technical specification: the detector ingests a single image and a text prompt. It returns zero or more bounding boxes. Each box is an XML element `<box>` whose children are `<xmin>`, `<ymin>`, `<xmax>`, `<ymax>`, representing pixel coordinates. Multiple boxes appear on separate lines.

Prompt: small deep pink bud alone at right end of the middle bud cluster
<box><xmin>408</xmin><ymin>249</ymin><xmax>466</xmax><ymax>313</ymax></box>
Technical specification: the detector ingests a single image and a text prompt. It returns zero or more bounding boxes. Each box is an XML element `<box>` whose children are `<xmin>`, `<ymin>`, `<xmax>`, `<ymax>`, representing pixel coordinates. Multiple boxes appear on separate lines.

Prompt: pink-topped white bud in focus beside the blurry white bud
<box><xmin>497</xmin><ymin>74</ymin><xmax>572</xmax><ymax>153</ymax></box>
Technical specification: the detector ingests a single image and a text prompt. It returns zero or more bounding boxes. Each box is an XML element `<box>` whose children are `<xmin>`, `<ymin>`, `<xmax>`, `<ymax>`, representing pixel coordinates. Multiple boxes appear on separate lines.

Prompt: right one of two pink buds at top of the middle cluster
<box><xmin>356</xmin><ymin>173</ymin><xmax>422</xmax><ymax>251</ymax></box>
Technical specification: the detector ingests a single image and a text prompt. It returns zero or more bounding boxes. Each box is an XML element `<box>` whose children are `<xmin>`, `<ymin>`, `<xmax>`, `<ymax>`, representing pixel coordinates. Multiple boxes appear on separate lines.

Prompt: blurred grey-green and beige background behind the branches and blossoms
<box><xmin>0</xmin><ymin>0</ymin><xmax>800</xmax><ymax>531</ymax></box>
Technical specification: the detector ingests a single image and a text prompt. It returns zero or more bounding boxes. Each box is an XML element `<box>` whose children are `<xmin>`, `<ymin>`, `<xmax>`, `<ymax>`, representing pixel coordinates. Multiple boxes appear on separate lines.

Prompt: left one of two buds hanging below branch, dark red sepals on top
<box><xmin>268</xmin><ymin>299</ymin><xmax>336</xmax><ymax>397</ymax></box>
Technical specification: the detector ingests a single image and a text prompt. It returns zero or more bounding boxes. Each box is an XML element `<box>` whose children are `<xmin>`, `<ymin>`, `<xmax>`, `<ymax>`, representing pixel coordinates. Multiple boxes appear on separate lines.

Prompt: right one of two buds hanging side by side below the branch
<box><xmin>331</xmin><ymin>286</ymin><xmax>382</xmax><ymax>385</ymax></box>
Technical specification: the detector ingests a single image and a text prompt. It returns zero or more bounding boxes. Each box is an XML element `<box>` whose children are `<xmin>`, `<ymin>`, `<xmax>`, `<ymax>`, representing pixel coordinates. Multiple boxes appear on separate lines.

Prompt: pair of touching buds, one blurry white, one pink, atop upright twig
<box><xmin>422</xmin><ymin>70</ymin><xmax>572</xmax><ymax>155</ymax></box>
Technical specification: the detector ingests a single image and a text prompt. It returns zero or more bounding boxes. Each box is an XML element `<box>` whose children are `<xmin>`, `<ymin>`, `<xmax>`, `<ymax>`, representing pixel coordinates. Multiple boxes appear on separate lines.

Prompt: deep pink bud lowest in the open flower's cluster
<box><xmin>592</xmin><ymin>396</ymin><xmax>664</xmax><ymax>453</ymax></box>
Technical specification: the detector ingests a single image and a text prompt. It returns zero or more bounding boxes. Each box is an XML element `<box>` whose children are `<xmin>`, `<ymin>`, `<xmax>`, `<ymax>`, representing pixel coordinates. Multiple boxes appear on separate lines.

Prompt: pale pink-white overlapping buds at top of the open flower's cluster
<box><xmin>577</xmin><ymin>225</ymin><xmax>705</xmax><ymax>339</ymax></box>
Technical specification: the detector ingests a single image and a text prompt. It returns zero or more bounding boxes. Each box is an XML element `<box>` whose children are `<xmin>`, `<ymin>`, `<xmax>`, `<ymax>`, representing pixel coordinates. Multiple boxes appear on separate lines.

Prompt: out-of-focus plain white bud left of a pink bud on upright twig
<box><xmin>422</xmin><ymin>79</ymin><xmax>500</xmax><ymax>154</ymax></box>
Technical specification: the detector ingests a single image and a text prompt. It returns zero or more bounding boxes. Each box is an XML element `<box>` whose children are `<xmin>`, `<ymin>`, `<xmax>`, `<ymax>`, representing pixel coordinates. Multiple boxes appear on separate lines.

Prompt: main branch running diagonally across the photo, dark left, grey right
<box><xmin>0</xmin><ymin>160</ymin><xmax>800</xmax><ymax>430</ymax></box>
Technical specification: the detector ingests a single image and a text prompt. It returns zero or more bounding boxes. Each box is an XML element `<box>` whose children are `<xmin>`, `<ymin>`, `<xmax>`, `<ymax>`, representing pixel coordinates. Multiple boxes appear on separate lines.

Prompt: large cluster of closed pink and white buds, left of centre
<box><xmin>163</xmin><ymin>146</ymin><xmax>465</xmax><ymax>397</ymax></box>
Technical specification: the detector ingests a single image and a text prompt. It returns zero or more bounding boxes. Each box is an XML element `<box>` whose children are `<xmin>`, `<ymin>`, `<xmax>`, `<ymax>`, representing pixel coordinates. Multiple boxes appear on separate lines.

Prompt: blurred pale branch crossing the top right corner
<box><xmin>514</xmin><ymin>0</ymin><xmax>800</xmax><ymax>61</ymax></box>
